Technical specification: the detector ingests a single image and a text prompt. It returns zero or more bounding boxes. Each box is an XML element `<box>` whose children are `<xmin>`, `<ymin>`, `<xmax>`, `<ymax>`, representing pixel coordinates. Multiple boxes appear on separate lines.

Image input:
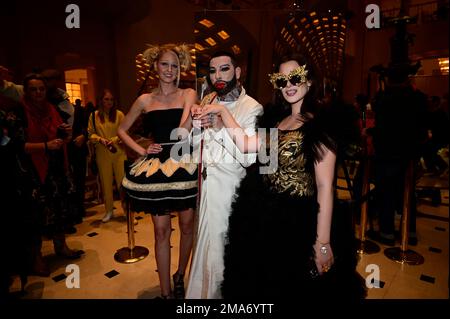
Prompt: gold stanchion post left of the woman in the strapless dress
<box><xmin>114</xmin><ymin>195</ymin><xmax>149</xmax><ymax>264</ymax></box>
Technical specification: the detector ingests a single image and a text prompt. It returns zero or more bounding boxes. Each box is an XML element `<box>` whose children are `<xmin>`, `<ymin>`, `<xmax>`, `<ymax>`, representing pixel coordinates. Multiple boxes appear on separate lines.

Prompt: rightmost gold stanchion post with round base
<box><xmin>384</xmin><ymin>160</ymin><xmax>425</xmax><ymax>265</ymax></box>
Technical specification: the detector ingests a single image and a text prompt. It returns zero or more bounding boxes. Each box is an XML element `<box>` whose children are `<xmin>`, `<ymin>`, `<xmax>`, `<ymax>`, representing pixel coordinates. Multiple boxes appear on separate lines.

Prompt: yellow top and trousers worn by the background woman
<box><xmin>88</xmin><ymin>110</ymin><xmax>126</xmax><ymax>212</ymax></box>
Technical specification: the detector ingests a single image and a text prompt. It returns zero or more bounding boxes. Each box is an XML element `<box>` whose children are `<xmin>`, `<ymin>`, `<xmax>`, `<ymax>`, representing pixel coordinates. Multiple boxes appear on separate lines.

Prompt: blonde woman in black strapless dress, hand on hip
<box><xmin>118</xmin><ymin>44</ymin><xmax>197</xmax><ymax>298</ymax></box>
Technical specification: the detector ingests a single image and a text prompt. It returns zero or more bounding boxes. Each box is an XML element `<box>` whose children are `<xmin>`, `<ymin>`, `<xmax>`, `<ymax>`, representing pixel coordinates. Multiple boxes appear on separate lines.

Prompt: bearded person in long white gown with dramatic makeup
<box><xmin>186</xmin><ymin>51</ymin><xmax>263</xmax><ymax>299</ymax></box>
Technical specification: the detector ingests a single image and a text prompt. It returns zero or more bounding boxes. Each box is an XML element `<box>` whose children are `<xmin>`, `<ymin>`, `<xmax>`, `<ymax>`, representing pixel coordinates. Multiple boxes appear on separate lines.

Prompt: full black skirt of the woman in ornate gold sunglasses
<box><xmin>222</xmin><ymin>165</ymin><xmax>365</xmax><ymax>300</ymax></box>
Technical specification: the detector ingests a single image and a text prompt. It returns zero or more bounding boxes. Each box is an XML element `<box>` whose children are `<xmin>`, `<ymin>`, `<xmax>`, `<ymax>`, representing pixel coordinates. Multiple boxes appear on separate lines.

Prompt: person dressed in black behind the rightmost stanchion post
<box><xmin>368</xmin><ymin>73</ymin><xmax>427</xmax><ymax>246</ymax></box>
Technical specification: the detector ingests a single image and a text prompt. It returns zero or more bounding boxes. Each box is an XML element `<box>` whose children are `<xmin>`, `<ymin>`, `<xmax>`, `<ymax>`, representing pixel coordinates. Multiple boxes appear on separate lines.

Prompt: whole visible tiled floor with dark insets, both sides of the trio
<box><xmin>8</xmin><ymin>178</ymin><xmax>449</xmax><ymax>299</ymax></box>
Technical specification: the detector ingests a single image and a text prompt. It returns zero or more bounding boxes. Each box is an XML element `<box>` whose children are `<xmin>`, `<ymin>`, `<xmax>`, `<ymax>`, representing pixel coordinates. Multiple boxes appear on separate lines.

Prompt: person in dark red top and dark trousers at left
<box><xmin>22</xmin><ymin>74</ymin><xmax>80</xmax><ymax>276</ymax></box>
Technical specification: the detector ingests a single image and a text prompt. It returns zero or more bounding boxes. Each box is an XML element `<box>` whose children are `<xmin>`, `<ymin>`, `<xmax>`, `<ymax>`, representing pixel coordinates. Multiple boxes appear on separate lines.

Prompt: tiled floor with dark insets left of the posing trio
<box><xmin>15</xmin><ymin>201</ymin><xmax>171</xmax><ymax>299</ymax></box>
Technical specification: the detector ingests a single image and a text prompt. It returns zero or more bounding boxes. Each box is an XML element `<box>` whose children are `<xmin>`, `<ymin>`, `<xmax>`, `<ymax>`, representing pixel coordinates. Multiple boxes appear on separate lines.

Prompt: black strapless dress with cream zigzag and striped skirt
<box><xmin>122</xmin><ymin>108</ymin><xmax>198</xmax><ymax>215</ymax></box>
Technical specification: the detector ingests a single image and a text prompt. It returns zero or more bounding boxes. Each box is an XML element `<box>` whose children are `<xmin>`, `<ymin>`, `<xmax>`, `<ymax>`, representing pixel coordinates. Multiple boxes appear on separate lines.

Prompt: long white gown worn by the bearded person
<box><xmin>186</xmin><ymin>89</ymin><xmax>263</xmax><ymax>299</ymax></box>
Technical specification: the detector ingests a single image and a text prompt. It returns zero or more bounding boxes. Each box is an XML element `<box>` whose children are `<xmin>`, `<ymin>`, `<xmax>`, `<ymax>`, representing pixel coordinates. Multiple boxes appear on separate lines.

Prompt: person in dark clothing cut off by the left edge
<box><xmin>0</xmin><ymin>96</ymin><xmax>35</xmax><ymax>300</ymax></box>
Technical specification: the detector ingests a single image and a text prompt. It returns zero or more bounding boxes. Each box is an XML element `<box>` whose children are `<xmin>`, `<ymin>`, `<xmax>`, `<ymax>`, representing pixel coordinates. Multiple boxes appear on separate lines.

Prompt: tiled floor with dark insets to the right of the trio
<box><xmin>357</xmin><ymin>212</ymin><xmax>449</xmax><ymax>299</ymax></box>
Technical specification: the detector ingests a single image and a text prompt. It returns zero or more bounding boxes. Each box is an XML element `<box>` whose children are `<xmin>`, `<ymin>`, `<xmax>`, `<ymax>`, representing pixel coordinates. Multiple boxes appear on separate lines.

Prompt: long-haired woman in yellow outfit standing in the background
<box><xmin>88</xmin><ymin>90</ymin><xmax>126</xmax><ymax>223</ymax></box>
